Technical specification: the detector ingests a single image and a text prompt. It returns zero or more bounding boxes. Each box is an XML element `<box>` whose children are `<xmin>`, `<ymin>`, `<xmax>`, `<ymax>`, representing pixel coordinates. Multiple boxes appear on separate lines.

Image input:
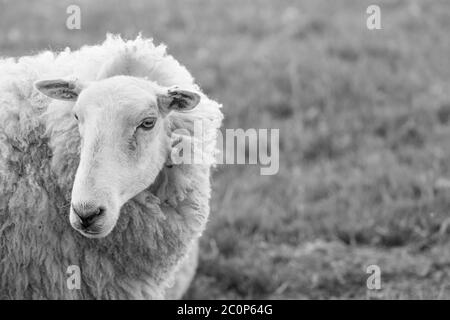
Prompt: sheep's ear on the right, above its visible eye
<box><xmin>157</xmin><ymin>87</ymin><xmax>200</xmax><ymax>114</ymax></box>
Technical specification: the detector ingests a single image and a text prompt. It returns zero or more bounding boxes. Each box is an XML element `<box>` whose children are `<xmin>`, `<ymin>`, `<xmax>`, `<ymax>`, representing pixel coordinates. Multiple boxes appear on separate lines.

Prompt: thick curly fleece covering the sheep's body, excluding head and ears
<box><xmin>0</xmin><ymin>36</ymin><xmax>222</xmax><ymax>299</ymax></box>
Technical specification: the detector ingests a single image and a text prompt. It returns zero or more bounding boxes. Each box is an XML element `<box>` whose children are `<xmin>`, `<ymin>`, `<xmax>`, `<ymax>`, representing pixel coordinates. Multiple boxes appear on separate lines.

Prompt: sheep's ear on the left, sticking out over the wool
<box><xmin>34</xmin><ymin>79</ymin><xmax>84</xmax><ymax>101</ymax></box>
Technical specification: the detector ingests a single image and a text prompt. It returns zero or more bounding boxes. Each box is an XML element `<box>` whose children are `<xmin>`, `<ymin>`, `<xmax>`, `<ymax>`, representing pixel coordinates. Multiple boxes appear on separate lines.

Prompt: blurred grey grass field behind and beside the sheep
<box><xmin>0</xmin><ymin>0</ymin><xmax>450</xmax><ymax>299</ymax></box>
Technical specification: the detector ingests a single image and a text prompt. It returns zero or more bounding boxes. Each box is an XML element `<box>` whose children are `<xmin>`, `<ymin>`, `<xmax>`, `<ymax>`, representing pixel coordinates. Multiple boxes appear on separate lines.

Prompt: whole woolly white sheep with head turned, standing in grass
<box><xmin>0</xmin><ymin>35</ymin><xmax>223</xmax><ymax>299</ymax></box>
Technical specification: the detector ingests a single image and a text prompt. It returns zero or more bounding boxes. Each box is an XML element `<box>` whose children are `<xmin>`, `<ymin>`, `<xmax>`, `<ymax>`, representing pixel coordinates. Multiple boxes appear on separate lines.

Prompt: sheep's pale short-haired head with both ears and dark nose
<box><xmin>35</xmin><ymin>76</ymin><xmax>200</xmax><ymax>238</ymax></box>
